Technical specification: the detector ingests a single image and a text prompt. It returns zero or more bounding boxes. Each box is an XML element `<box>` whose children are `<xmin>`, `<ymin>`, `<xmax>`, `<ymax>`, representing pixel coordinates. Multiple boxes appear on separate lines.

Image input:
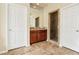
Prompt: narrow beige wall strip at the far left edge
<box><xmin>0</xmin><ymin>4</ymin><xmax>7</xmax><ymax>53</ymax></box>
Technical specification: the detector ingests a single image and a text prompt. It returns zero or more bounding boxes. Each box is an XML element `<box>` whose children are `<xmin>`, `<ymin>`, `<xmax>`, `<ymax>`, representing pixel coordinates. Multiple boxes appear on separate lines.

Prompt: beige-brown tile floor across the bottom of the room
<box><xmin>2</xmin><ymin>41</ymin><xmax>79</xmax><ymax>55</ymax></box>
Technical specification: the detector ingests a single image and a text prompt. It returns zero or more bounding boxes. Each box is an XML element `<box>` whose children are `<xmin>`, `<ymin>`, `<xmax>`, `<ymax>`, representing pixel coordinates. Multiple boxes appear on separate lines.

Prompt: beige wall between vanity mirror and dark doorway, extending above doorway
<box><xmin>43</xmin><ymin>3</ymin><xmax>71</xmax><ymax>40</ymax></box>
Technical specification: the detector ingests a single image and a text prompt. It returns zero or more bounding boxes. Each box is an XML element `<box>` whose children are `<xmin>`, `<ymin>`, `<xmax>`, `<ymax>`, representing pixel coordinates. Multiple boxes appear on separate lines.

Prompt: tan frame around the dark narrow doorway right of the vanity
<box><xmin>48</xmin><ymin>9</ymin><xmax>60</xmax><ymax>45</ymax></box>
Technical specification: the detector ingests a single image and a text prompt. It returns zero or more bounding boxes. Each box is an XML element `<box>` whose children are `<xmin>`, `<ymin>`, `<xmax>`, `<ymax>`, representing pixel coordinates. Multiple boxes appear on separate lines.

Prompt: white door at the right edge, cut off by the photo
<box><xmin>60</xmin><ymin>4</ymin><xmax>79</xmax><ymax>52</ymax></box>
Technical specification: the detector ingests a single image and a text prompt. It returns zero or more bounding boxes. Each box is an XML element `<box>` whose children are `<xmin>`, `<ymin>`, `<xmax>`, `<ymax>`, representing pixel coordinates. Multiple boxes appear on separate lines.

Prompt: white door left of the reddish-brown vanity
<box><xmin>8</xmin><ymin>4</ymin><xmax>27</xmax><ymax>49</ymax></box>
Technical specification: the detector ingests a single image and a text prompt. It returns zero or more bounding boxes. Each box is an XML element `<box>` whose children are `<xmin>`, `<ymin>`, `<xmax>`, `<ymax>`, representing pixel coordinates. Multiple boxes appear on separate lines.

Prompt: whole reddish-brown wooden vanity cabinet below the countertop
<box><xmin>30</xmin><ymin>30</ymin><xmax>47</xmax><ymax>44</ymax></box>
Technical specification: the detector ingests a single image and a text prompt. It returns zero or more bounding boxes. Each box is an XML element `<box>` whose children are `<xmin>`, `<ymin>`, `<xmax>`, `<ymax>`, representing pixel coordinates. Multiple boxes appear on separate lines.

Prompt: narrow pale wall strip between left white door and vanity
<box><xmin>20</xmin><ymin>3</ymin><xmax>30</xmax><ymax>47</ymax></box>
